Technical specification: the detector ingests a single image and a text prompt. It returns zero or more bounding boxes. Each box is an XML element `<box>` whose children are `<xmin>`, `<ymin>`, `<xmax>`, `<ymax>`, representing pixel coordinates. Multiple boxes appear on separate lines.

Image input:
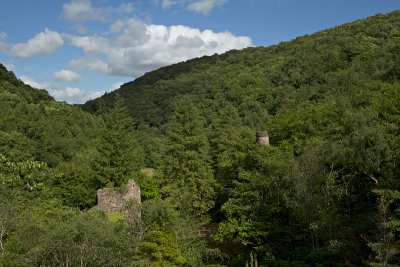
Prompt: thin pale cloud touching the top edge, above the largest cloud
<box><xmin>62</xmin><ymin>0</ymin><xmax>134</xmax><ymax>22</ymax></box>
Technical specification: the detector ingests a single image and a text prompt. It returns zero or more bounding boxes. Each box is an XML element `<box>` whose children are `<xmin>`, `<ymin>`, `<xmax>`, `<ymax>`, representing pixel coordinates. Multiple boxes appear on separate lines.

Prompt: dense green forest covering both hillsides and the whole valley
<box><xmin>0</xmin><ymin>12</ymin><xmax>400</xmax><ymax>266</ymax></box>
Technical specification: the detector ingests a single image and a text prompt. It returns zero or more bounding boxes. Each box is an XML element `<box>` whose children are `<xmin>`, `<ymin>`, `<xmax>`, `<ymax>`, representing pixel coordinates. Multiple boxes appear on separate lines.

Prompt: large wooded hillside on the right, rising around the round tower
<box><xmin>83</xmin><ymin>11</ymin><xmax>400</xmax><ymax>266</ymax></box>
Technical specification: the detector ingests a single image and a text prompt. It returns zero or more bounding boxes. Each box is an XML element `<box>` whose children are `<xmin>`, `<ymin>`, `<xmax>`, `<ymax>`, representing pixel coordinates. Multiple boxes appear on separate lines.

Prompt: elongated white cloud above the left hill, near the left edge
<box><xmin>10</xmin><ymin>29</ymin><xmax>64</xmax><ymax>58</ymax></box>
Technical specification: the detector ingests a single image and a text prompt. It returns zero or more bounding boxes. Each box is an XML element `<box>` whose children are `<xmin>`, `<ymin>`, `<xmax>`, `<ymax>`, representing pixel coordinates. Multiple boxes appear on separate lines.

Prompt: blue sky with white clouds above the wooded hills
<box><xmin>0</xmin><ymin>0</ymin><xmax>400</xmax><ymax>104</ymax></box>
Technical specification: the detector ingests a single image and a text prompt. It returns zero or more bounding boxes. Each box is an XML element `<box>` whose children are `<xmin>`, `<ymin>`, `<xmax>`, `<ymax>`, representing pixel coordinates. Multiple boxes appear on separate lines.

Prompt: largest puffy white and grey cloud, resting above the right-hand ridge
<box><xmin>66</xmin><ymin>19</ymin><xmax>252</xmax><ymax>77</ymax></box>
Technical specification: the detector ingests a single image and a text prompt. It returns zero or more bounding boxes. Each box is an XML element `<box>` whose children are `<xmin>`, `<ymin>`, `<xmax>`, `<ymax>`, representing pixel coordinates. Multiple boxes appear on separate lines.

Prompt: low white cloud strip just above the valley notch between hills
<box><xmin>20</xmin><ymin>76</ymin><xmax>105</xmax><ymax>104</ymax></box>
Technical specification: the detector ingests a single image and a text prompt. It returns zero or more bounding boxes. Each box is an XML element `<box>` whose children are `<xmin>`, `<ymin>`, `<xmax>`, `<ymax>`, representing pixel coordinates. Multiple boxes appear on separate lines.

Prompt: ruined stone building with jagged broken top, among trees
<box><xmin>96</xmin><ymin>179</ymin><xmax>141</xmax><ymax>213</ymax></box>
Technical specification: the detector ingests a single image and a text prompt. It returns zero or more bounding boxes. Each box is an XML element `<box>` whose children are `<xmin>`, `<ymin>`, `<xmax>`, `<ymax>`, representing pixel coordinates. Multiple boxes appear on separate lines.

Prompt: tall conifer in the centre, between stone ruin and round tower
<box><xmin>163</xmin><ymin>97</ymin><xmax>215</xmax><ymax>216</ymax></box>
